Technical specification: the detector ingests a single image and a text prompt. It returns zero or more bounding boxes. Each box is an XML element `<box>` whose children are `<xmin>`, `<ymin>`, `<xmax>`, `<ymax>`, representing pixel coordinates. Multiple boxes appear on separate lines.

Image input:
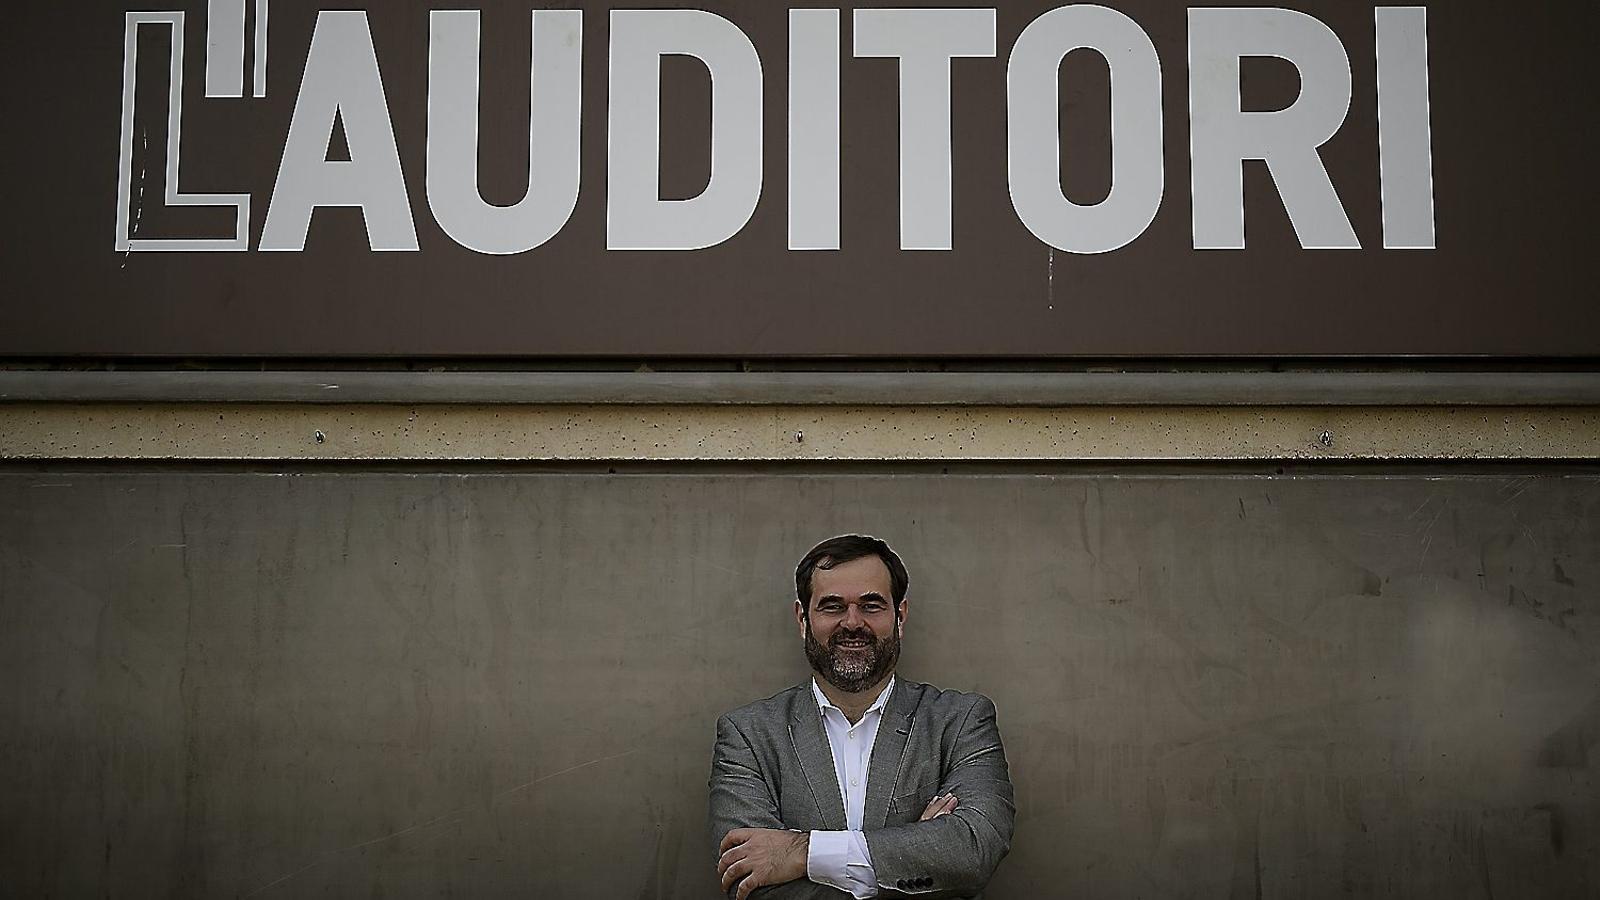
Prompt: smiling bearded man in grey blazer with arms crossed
<box><xmin>710</xmin><ymin>535</ymin><xmax>1014</xmax><ymax>900</ymax></box>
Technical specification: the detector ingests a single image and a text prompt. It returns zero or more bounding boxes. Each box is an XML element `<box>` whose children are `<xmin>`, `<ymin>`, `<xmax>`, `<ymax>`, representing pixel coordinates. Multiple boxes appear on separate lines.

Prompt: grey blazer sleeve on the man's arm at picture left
<box><xmin>709</xmin><ymin>716</ymin><xmax>851</xmax><ymax>900</ymax></box>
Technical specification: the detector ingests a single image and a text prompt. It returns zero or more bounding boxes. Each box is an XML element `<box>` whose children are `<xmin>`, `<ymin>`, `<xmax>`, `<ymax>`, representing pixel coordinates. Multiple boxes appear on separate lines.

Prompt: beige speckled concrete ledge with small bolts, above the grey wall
<box><xmin>0</xmin><ymin>404</ymin><xmax>1600</xmax><ymax>461</ymax></box>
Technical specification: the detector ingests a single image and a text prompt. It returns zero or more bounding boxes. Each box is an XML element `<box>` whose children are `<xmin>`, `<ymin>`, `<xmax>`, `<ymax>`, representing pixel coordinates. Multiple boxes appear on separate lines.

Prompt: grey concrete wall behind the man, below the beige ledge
<box><xmin>0</xmin><ymin>464</ymin><xmax>1600</xmax><ymax>900</ymax></box>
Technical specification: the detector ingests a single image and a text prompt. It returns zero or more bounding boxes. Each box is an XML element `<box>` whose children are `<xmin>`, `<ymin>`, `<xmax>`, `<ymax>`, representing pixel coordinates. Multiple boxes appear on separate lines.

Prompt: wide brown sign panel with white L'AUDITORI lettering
<box><xmin>0</xmin><ymin>0</ymin><xmax>1600</xmax><ymax>357</ymax></box>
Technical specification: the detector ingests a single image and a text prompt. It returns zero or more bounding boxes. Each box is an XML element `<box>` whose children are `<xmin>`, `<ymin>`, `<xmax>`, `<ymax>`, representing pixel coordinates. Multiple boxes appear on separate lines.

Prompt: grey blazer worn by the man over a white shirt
<box><xmin>710</xmin><ymin>677</ymin><xmax>1016</xmax><ymax>900</ymax></box>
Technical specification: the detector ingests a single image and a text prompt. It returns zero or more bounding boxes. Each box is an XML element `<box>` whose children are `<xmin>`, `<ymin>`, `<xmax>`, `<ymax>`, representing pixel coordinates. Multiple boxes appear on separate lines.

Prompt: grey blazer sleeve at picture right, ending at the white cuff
<box><xmin>866</xmin><ymin>695</ymin><xmax>1016</xmax><ymax>895</ymax></box>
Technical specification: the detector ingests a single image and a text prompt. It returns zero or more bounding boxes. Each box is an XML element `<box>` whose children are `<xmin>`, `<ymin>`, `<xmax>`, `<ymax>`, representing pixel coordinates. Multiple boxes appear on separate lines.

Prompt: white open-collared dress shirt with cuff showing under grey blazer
<box><xmin>805</xmin><ymin>676</ymin><xmax>894</xmax><ymax>898</ymax></box>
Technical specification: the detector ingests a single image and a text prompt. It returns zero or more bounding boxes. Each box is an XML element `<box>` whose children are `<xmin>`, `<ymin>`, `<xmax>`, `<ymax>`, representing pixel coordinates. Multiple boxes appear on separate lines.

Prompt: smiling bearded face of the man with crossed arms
<box><xmin>795</xmin><ymin>556</ymin><xmax>906</xmax><ymax>693</ymax></box>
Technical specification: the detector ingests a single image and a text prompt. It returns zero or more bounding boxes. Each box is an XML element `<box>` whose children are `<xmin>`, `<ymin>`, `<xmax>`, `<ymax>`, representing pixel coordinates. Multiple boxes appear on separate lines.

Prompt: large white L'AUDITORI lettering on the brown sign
<box><xmin>117</xmin><ymin>5</ymin><xmax>1434</xmax><ymax>255</ymax></box>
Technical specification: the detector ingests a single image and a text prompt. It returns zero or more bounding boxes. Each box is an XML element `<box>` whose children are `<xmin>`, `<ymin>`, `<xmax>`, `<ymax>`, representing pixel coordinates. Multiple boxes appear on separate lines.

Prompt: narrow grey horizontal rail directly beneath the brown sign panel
<box><xmin>9</xmin><ymin>370</ymin><xmax>1600</xmax><ymax>407</ymax></box>
